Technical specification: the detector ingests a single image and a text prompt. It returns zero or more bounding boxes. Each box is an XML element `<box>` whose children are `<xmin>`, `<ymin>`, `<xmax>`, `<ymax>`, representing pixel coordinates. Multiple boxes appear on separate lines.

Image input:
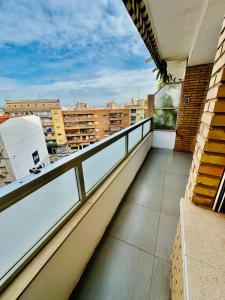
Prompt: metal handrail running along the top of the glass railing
<box><xmin>0</xmin><ymin>118</ymin><xmax>151</xmax><ymax>212</ymax></box>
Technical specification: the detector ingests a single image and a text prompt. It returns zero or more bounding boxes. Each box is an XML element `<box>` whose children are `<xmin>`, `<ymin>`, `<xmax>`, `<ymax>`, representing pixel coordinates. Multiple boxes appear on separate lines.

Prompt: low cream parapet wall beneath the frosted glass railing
<box><xmin>1</xmin><ymin>133</ymin><xmax>152</xmax><ymax>300</ymax></box>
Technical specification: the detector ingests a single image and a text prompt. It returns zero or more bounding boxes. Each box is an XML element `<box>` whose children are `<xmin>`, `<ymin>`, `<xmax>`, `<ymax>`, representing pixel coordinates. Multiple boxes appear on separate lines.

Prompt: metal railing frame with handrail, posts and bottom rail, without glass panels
<box><xmin>0</xmin><ymin>118</ymin><xmax>152</xmax><ymax>291</ymax></box>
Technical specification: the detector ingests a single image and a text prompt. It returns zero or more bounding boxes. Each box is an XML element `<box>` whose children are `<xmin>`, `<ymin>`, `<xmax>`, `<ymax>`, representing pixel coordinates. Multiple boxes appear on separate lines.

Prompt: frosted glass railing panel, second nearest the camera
<box><xmin>82</xmin><ymin>137</ymin><xmax>125</xmax><ymax>192</ymax></box>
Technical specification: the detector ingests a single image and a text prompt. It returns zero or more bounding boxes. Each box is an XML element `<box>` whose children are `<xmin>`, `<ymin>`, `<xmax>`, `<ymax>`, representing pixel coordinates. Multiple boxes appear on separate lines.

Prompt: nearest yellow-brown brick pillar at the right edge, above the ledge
<box><xmin>186</xmin><ymin>16</ymin><xmax>225</xmax><ymax>207</ymax></box>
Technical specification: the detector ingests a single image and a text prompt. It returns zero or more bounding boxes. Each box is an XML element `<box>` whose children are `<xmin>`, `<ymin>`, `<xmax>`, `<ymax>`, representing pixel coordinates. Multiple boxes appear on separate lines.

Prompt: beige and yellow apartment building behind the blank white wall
<box><xmin>5</xmin><ymin>99</ymin><xmax>67</xmax><ymax>152</ymax></box>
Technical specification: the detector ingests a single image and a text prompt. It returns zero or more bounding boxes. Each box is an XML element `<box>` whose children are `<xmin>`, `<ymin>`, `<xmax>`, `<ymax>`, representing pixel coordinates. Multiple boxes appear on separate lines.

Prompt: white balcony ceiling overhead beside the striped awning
<box><xmin>145</xmin><ymin>0</ymin><xmax>225</xmax><ymax>65</ymax></box>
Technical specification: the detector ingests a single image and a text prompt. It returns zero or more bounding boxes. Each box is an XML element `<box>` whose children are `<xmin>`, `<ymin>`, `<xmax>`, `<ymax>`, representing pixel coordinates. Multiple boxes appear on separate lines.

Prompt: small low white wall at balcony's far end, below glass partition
<box><xmin>152</xmin><ymin>130</ymin><xmax>176</xmax><ymax>149</ymax></box>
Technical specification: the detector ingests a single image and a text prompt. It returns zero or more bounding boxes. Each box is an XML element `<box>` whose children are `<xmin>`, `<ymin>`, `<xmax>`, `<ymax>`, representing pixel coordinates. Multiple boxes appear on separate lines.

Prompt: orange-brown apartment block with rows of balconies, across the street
<box><xmin>62</xmin><ymin>106</ymin><xmax>130</xmax><ymax>149</ymax></box>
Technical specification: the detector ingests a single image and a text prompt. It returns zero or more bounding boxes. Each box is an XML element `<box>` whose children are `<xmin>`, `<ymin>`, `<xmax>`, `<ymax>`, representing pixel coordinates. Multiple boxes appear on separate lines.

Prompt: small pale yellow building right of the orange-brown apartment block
<box><xmin>124</xmin><ymin>98</ymin><xmax>147</xmax><ymax>125</ymax></box>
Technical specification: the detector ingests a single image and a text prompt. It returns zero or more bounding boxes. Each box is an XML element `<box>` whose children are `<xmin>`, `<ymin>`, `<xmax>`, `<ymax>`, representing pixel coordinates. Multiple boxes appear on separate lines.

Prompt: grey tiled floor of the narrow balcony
<box><xmin>71</xmin><ymin>148</ymin><xmax>192</xmax><ymax>300</ymax></box>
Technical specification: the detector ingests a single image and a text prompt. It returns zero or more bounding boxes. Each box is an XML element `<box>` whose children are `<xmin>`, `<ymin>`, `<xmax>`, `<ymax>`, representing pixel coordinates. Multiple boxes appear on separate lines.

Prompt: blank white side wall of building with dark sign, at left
<box><xmin>0</xmin><ymin>116</ymin><xmax>50</xmax><ymax>179</ymax></box>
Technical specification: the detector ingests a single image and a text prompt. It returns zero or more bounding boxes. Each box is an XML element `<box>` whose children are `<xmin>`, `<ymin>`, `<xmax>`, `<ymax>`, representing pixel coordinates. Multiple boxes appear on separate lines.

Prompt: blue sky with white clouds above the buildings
<box><xmin>0</xmin><ymin>0</ymin><xmax>156</xmax><ymax>106</ymax></box>
